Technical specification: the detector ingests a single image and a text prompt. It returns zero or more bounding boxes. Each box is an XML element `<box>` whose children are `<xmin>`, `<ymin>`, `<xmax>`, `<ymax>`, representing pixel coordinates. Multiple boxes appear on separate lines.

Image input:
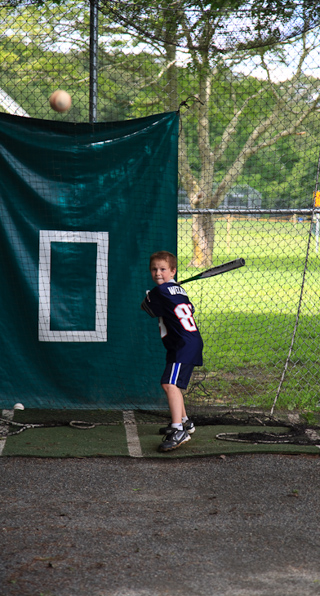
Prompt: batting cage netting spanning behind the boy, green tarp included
<box><xmin>0</xmin><ymin>0</ymin><xmax>320</xmax><ymax>412</ymax></box>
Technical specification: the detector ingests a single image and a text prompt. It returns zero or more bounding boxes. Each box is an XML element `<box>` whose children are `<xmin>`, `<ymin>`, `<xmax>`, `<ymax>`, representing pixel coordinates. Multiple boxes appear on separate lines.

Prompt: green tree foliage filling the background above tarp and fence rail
<box><xmin>0</xmin><ymin>0</ymin><xmax>319</xmax><ymax>208</ymax></box>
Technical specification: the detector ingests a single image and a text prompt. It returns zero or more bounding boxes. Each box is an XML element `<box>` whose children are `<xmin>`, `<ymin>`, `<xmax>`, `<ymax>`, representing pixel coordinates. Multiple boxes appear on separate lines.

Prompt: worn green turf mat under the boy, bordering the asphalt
<box><xmin>2</xmin><ymin>409</ymin><xmax>320</xmax><ymax>458</ymax></box>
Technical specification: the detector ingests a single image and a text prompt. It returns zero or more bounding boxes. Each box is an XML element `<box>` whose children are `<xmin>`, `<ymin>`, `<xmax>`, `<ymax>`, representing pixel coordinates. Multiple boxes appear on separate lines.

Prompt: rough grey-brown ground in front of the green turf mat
<box><xmin>0</xmin><ymin>455</ymin><xmax>320</xmax><ymax>596</ymax></box>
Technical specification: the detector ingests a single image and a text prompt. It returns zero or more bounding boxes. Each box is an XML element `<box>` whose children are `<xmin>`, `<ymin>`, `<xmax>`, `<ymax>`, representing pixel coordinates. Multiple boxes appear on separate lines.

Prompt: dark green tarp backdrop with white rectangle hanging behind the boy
<box><xmin>0</xmin><ymin>112</ymin><xmax>179</xmax><ymax>409</ymax></box>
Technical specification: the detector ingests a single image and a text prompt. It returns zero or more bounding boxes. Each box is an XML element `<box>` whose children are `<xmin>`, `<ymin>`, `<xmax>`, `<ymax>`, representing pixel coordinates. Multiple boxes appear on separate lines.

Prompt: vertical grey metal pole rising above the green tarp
<box><xmin>89</xmin><ymin>0</ymin><xmax>99</xmax><ymax>123</ymax></box>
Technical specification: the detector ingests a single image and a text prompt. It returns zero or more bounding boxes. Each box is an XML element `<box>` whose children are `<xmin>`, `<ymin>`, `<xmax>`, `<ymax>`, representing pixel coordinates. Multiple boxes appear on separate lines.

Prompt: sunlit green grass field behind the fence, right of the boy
<box><xmin>178</xmin><ymin>219</ymin><xmax>320</xmax><ymax>411</ymax></box>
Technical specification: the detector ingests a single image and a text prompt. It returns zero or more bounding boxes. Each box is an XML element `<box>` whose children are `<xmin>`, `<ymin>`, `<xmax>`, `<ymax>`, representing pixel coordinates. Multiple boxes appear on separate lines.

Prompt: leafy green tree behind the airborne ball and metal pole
<box><xmin>0</xmin><ymin>0</ymin><xmax>174</xmax><ymax>121</ymax></box>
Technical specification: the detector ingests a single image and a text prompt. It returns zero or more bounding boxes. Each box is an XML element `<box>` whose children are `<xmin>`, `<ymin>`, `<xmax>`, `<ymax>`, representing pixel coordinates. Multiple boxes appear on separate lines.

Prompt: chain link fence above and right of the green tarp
<box><xmin>0</xmin><ymin>0</ymin><xmax>320</xmax><ymax>411</ymax></box>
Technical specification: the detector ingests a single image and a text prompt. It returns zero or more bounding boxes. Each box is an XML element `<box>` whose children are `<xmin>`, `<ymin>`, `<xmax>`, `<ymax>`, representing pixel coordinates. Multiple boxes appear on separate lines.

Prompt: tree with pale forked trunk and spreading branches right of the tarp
<box><xmin>104</xmin><ymin>0</ymin><xmax>319</xmax><ymax>267</ymax></box>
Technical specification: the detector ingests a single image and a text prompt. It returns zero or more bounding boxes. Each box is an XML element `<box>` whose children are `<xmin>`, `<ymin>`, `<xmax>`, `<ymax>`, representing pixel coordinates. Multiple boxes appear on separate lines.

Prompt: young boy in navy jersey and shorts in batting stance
<box><xmin>141</xmin><ymin>251</ymin><xmax>203</xmax><ymax>452</ymax></box>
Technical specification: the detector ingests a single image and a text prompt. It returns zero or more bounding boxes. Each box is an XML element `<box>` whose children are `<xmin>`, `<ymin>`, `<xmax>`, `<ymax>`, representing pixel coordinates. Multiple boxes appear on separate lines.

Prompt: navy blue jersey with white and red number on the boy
<box><xmin>141</xmin><ymin>281</ymin><xmax>203</xmax><ymax>366</ymax></box>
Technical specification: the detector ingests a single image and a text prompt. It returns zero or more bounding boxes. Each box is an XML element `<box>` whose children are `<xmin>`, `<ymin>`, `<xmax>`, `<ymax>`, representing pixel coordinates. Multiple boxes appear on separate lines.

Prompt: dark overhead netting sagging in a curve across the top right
<box><xmin>99</xmin><ymin>0</ymin><xmax>320</xmax><ymax>53</ymax></box>
